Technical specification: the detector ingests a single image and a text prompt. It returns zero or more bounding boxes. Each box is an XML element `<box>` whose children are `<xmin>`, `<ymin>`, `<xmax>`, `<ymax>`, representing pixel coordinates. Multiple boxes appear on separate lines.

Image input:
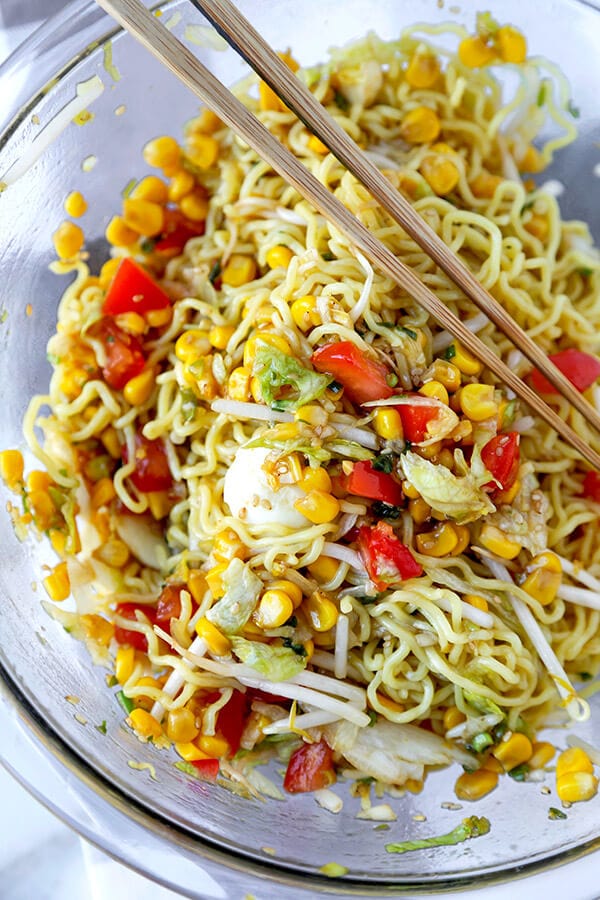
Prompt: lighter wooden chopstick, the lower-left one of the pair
<box><xmin>97</xmin><ymin>0</ymin><xmax>600</xmax><ymax>469</ymax></box>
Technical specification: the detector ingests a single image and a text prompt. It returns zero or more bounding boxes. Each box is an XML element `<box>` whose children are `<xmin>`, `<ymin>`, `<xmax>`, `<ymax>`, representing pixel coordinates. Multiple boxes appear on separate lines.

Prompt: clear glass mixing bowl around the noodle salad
<box><xmin>0</xmin><ymin>0</ymin><xmax>600</xmax><ymax>897</ymax></box>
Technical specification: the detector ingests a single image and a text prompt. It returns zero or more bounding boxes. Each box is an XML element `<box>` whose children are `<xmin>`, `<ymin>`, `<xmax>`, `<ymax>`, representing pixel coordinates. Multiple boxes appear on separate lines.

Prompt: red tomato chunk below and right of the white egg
<box><xmin>358</xmin><ymin>522</ymin><xmax>423</xmax><ymax>591</ymax></box>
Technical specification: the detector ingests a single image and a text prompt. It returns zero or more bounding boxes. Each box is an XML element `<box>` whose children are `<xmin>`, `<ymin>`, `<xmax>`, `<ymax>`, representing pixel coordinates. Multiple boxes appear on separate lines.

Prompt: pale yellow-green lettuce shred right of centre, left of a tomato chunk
<box><xmin>401</xmin><ymin>450</ymin><xmax>496</xmax><ymax>525</ymax></box>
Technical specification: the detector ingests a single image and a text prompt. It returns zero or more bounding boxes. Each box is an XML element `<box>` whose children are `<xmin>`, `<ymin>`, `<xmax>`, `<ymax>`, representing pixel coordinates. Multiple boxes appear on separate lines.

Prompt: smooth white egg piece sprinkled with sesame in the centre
<box><xmin>223</xmin><ymin>447</ymin><xmax>310</xmax><ymax>528</ymax></box>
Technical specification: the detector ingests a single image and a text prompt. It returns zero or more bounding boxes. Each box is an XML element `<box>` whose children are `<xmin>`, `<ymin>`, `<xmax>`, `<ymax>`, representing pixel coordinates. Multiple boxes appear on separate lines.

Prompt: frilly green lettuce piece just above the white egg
<box><xmin>252</xmin><ymin>340</ymin><xmax>331</xmax><ymax>410</ymax></box>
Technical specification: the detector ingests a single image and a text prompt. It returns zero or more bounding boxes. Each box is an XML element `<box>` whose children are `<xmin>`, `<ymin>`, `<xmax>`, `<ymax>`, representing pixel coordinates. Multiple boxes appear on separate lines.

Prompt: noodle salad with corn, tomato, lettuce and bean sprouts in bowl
<box><xmin>0</xmin><ymin>14</ymin><xmax>600</xmax><ymax>816</ymax></box>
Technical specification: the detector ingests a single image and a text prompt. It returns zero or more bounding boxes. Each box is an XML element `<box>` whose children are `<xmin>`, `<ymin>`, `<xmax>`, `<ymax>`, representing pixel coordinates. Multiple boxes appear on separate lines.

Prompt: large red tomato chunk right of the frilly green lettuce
<box><xmin>312</xmin><ymin>341</ymin><xmax>394</xmax><ymax>404</ymax></box>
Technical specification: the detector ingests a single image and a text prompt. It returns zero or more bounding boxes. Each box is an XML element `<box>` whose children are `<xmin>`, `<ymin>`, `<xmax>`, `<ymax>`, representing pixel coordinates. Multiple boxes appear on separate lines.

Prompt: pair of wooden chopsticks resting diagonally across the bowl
<box><xmin>97</xmin><ymin>0</ymin><xmax>600</xmax><ymax>469</ymax></box>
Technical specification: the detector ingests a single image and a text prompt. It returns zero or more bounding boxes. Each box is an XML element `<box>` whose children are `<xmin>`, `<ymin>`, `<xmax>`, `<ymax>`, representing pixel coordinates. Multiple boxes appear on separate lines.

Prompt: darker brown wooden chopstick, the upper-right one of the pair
<box><xmin>191</xmin><ymin>0</ymin><xmax>600</xmax><ymax>440</ymax></box>
